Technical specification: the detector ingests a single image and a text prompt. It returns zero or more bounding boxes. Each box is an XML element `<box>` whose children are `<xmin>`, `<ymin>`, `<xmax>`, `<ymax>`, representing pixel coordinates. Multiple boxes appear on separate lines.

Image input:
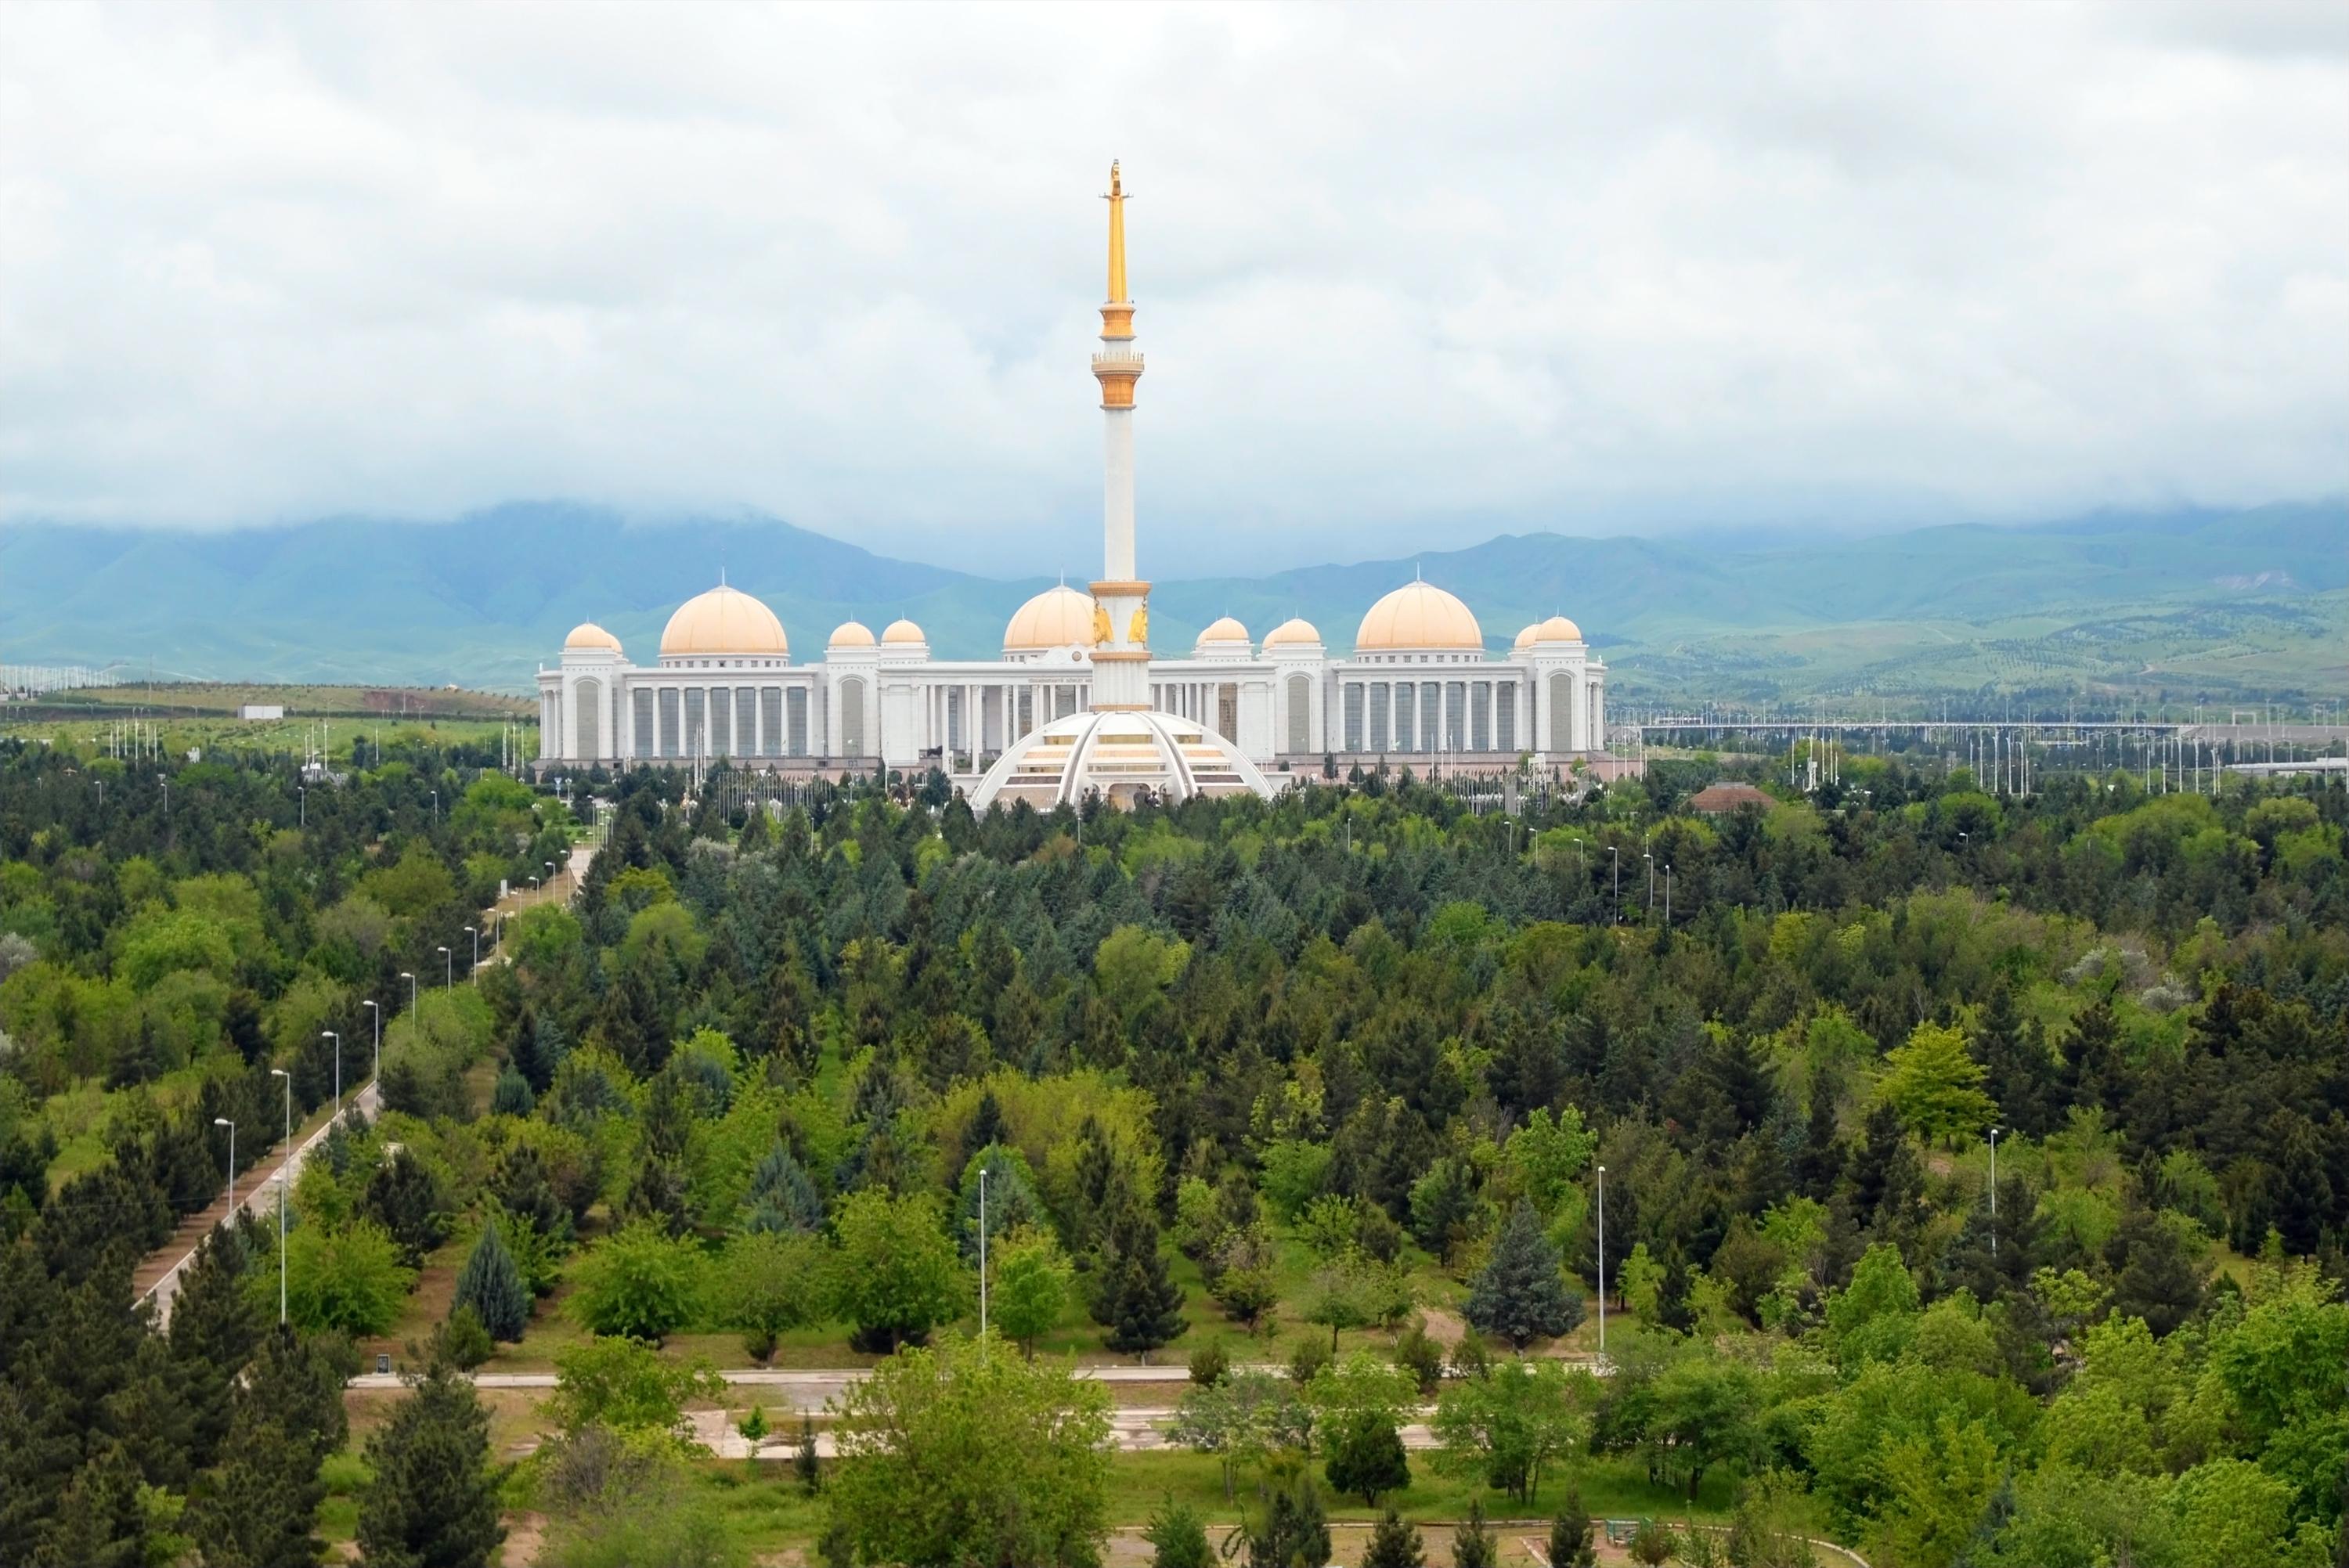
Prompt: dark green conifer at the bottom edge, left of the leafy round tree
<box><xmin>359</xmin><ymin>1366</ymin><xmax>505</xmax><ymax>1568</ymax></box>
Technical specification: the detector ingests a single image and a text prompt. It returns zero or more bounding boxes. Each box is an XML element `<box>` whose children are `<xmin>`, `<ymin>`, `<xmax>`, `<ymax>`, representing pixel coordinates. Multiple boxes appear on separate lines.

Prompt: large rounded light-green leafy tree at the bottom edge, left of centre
<box><xmin>829</xmin><ymin>1338</ymin><xmax>1111</xmax><ymax>1568</ymax></box>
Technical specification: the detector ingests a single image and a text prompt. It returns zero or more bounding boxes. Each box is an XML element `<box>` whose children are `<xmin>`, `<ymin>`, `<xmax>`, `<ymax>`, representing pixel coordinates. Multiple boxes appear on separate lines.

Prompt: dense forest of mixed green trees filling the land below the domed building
<box><xmin>0</xmin><ymin>747</ymin><xmax>2349</xmax><ymax>1568</ymax></box>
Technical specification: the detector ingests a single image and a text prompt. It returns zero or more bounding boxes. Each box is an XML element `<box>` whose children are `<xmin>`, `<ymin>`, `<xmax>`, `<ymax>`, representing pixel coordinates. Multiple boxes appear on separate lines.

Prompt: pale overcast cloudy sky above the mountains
<box><xmin>0</xmin><ymin>0</ymin><xmax>2349</xmax><ymax>575</ymax></box>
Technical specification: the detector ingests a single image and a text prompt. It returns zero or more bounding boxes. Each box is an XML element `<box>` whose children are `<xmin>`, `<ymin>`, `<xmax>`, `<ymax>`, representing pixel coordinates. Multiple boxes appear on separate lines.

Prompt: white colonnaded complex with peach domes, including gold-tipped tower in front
<box><xmin>538</xmin><ymin>164</ymin><xmax>1607</xmax><ymax>788</ymax></box>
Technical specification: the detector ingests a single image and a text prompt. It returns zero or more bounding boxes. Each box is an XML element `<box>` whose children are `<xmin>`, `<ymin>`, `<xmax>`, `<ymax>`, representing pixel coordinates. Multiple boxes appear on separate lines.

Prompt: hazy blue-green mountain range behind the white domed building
<box><xmin>0</xmin><ymin>500</ymin><xmax>2349</xmax><ymax>690</ymax></box>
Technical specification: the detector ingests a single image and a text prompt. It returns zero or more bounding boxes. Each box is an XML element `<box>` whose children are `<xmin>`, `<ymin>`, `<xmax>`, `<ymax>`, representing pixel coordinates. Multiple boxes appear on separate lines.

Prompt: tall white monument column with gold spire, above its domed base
<box><xmin>1092</xmin><ymin>162</ymin><xmax>1151</xmax><ymax>714</ymax></box>
